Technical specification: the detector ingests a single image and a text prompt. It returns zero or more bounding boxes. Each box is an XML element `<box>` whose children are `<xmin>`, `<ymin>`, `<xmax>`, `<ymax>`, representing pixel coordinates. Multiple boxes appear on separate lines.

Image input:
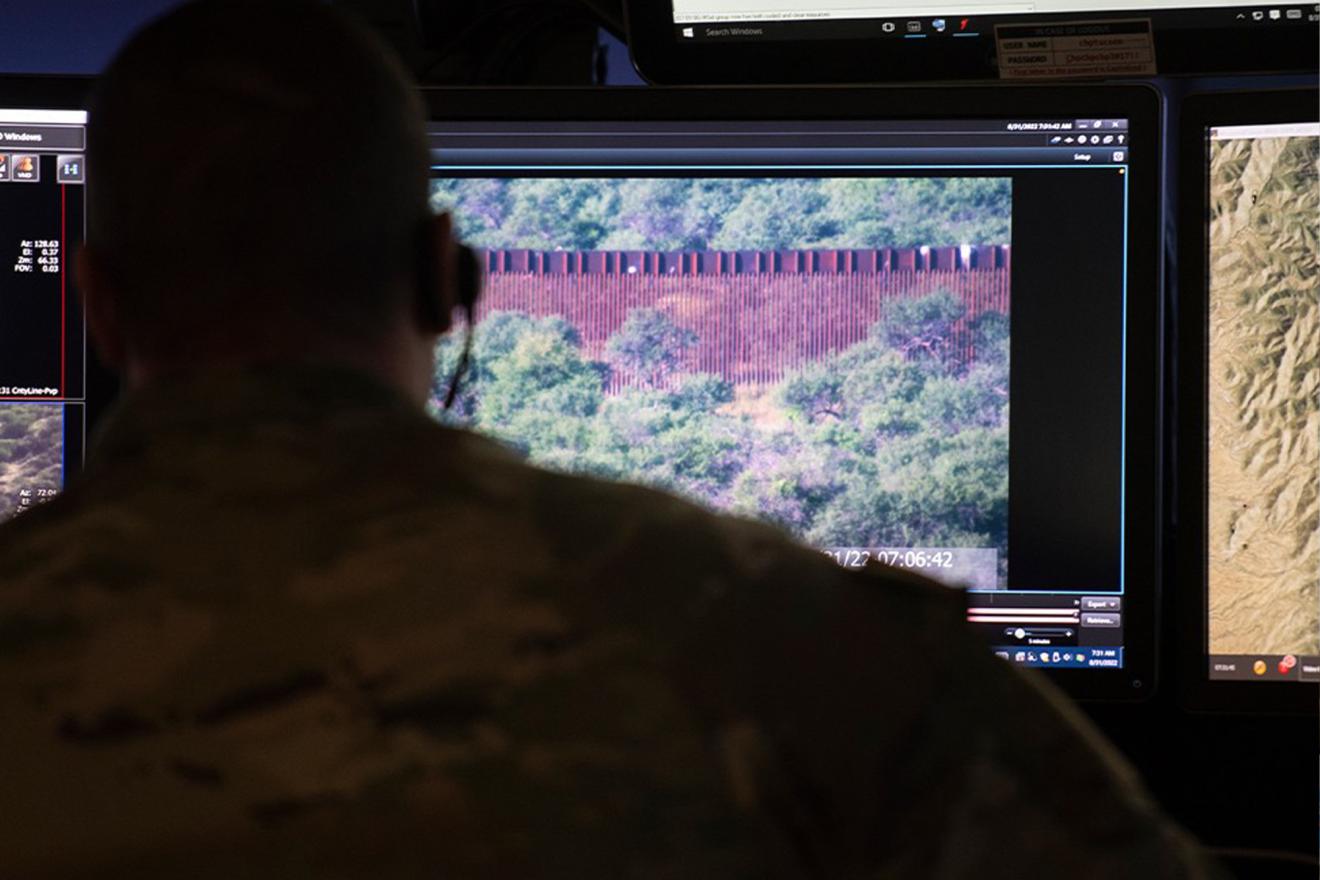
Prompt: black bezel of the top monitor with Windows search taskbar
<box><xmin>623</xmin><ymin>0</ymin><xmax>1320</xmax><ymax>84</ymax></box>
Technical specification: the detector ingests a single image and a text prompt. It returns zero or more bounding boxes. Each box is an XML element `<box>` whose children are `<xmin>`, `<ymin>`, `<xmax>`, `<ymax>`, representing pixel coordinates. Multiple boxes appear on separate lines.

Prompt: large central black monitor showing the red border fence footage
<box><xmin>426</xmin><ymin>87</ymin><xmax>1160</xmax><ymax>698</ymax></box>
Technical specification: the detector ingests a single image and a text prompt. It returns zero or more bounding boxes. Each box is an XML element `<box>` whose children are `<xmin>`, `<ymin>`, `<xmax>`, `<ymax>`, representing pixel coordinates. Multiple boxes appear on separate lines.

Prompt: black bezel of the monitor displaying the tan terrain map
<box><xmin>1172</xmin><ymin>88</ymin><xmax>1320</xmax><ymax>715</ymax></box>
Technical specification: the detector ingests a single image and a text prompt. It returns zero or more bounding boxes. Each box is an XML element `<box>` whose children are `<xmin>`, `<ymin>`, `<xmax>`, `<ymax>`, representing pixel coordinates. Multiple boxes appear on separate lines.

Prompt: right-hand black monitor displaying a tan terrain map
<box><xmin>1177</xmin><ymin>90</ymin><xmax>1320</xmax><ymax>712</ymax></box>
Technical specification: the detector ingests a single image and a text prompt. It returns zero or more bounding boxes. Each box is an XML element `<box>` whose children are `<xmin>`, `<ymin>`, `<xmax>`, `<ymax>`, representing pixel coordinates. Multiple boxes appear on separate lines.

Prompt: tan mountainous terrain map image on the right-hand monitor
<box><xmin>1206</xmin><ymin>129</ymin><xmax>1320</xmax><ymax>674</ymax></box>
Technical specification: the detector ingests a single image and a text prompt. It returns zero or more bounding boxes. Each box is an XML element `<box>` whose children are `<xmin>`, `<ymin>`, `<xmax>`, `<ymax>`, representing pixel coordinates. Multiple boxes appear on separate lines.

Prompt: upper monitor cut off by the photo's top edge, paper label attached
<box><xmin>624</xmin><ymin>0</ymin><xmax>1320</xmax><ymax>84</ymax></box>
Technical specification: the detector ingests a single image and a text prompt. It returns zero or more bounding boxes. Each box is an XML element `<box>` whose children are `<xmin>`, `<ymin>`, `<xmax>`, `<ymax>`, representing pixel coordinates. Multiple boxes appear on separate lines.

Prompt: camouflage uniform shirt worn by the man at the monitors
<box><xmin>0</xmin><ymin>368</ymin><xmax>1208</xmax><ymax>880</ymax></box>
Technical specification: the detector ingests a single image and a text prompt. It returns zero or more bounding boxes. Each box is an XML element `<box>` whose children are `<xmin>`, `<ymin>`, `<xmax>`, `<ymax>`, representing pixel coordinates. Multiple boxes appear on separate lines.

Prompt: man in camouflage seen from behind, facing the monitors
<box><xmin>0</xmin><ymin>0</ymin><xmax>1224</xmax><ymax>880</ymax></box>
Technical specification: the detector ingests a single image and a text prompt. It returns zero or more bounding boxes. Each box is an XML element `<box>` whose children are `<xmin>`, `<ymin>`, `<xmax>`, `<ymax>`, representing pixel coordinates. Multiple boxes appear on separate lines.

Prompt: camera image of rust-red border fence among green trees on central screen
<box><xmin>432</xmin><ymin>177</ymin><xmax>1012</xmax><ymax>590</ymax></box>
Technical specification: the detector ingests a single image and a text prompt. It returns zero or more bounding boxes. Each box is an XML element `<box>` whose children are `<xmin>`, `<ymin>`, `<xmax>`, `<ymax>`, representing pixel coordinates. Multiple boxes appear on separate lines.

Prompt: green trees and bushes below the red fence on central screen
<box><xmin>434</xmin><ymin>292</ymin><xmax>1008</xmax><ymax>577</ymax></box>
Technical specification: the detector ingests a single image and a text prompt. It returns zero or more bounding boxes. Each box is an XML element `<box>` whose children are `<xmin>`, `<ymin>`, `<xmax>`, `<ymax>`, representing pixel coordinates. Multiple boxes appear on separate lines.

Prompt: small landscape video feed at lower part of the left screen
<box><xmin>0</xmin><ymin>404</ymin><xmax>65</xmax><ymax>520</ymax></box>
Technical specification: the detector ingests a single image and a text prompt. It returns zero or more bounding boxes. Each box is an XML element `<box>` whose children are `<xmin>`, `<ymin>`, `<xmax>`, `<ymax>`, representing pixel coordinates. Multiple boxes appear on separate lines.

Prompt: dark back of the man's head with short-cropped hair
<box><xmin>79</xmin><ymin>0</ymin><xmax>453</xmax><ymax>391</ymax></box>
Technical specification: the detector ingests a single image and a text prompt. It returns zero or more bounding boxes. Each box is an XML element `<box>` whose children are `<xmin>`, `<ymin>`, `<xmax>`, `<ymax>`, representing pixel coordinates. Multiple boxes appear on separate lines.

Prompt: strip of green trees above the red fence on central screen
<box><xmin>432</xmin><ymin>177</ymin><xmax>1012</xmax><ymax>251</ymax></box>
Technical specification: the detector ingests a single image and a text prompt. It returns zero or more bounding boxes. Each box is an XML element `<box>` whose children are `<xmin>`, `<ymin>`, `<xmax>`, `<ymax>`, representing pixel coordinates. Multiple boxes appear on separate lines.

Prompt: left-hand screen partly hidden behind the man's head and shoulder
<box><xmin>0</xmin><ymin>107</ymin><xmax>87</xmax><ymax>520</ymax></box>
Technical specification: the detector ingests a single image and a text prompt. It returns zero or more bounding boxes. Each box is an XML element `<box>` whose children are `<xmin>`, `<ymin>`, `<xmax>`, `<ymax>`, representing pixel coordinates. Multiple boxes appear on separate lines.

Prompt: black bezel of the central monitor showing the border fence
<box><xmin>424</xmin><ymin>86</ymin><xmax>1163</xmax><ymax>701</ymax></box>
